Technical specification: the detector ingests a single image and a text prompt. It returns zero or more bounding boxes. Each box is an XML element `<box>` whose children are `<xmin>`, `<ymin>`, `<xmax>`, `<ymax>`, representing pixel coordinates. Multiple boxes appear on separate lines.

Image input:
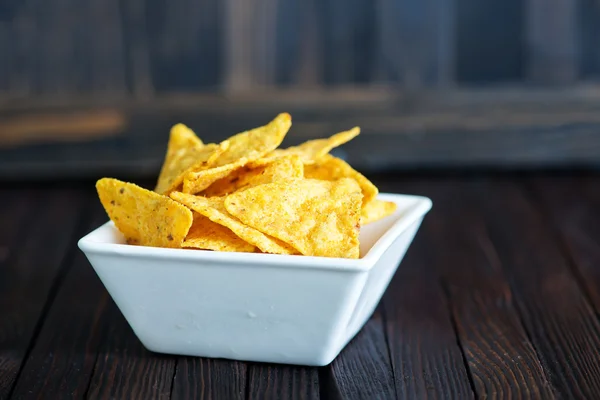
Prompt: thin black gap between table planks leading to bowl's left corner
<box><xmin>8</xmin><ymin>194</ymin><xmax>91</xmax><ymax>398</ymax></box>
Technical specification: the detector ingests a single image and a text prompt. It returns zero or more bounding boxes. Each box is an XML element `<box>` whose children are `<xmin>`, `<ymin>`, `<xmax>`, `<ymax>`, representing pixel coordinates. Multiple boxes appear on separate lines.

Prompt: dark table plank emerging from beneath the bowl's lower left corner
<box><xmin>87</xmin><ymin>298</ymin><xmax>176</xmax><ymax>399</ymax></box>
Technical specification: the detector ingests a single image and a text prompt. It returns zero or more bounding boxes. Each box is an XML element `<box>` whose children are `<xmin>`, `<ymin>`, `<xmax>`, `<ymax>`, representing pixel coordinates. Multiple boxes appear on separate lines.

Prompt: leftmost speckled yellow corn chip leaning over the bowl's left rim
<box><xmin>96</xmin><ymin>178</ymin><xmax>193</xmax><ymax>247</ymax></box>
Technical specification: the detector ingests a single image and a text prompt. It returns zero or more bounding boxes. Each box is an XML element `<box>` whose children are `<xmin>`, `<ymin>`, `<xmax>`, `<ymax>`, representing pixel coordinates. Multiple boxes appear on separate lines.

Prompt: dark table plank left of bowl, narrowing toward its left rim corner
<box><xmin>12</xmin><ymin>197</ymin><xmax>116</xmax><ymax>399</ymax></box>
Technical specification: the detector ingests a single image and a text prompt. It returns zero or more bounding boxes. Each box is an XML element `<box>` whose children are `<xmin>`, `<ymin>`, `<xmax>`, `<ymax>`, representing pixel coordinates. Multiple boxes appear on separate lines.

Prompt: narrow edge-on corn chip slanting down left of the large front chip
<box><xmin>171</xmin><ymin>192</ymin><xmax>298</xmax><ymax>254</ymax></box>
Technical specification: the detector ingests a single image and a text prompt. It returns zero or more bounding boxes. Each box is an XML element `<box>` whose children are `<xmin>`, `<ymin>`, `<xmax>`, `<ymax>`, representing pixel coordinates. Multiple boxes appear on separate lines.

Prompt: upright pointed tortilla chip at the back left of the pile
<box><xmin>154</xmin><ymin>124</ymin><xmax>229</xmax><ymax>194</ymax></box>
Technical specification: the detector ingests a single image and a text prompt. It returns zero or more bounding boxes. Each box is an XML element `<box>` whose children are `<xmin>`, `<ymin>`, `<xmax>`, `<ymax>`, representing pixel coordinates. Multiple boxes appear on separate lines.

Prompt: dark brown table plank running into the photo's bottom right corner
<box><xmin>473</xmin><ymin>180</ymin><xmax>600</xmax><ymax>398</ymax></box>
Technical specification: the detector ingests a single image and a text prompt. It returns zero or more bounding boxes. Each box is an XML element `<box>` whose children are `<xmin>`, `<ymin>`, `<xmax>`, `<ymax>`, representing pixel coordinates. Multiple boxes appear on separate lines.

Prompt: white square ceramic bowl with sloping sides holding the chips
<box><xmin>79</xmin><ymin>194</ymin><xmax>431</xmax><ymax>366</ymax></box>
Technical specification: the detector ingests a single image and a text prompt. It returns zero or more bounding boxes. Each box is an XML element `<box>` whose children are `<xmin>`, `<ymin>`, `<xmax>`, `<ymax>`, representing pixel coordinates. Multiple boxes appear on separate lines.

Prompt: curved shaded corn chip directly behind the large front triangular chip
<box><xmin>202</xmin><ymin>156</ymin><xmax>304</xmax><ymax>197</ymax></box>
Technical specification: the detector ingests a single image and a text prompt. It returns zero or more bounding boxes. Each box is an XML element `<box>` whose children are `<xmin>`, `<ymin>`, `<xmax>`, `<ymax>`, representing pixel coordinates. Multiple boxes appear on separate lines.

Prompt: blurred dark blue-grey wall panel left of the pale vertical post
<box><xmin>145</xmin><ymin>0</ymin><xmax>223</xmax><ymax>92</ymax></box>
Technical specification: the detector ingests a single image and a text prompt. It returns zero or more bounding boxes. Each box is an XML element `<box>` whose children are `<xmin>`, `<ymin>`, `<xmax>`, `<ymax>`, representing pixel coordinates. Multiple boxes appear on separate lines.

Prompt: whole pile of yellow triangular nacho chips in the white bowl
<box><xmin>96</xmin><ymin>113</ymin><xmax>396</xmax><ymax>258</ymax></box>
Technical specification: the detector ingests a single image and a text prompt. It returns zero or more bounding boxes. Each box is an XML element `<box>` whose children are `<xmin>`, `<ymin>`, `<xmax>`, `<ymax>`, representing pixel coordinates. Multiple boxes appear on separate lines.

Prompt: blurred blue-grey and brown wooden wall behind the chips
<box><xmin>0</xmin><ymin>0</ymin><xmax>600</xmax><ymax>180</ymax></box>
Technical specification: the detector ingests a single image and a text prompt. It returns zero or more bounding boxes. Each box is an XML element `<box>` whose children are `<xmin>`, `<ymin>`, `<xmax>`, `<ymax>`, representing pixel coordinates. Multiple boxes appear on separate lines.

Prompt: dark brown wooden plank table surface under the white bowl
<box><xmin>0</xmin><ymin>174</ymin><xmax>600</xmax><ymax>399</ymax></box>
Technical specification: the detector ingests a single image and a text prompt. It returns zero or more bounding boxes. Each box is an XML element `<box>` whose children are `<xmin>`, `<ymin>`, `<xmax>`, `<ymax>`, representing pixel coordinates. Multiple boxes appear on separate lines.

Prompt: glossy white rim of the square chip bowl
<box><xmin>77</xmin><ymin>193</ymin><xmax>432</xmax><ymax>271</ymax></box>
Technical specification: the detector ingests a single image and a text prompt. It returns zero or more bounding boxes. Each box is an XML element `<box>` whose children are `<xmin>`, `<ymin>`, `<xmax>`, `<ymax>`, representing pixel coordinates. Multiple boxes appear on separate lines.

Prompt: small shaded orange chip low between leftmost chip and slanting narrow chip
<box><xmin>181</xmin><ymin>213</ymin><xmax>256</xmax><ymax>253</ymax></box>
